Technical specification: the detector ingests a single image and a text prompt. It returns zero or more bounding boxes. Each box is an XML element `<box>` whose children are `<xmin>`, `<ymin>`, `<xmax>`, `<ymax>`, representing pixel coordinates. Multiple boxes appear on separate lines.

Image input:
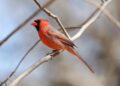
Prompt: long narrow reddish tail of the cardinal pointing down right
<box><xmin>66</xmin><ymin>47</ymin><xmax>94</xmax><ymax>73</ymax></box>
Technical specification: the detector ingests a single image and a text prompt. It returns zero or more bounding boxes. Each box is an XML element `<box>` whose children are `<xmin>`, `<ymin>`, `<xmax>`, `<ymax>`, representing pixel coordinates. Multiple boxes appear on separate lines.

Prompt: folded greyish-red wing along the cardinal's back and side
<box><xmin>47</xmin><ymin>26</ymin><xmax>75</xmax><ymax>47</ymax></box>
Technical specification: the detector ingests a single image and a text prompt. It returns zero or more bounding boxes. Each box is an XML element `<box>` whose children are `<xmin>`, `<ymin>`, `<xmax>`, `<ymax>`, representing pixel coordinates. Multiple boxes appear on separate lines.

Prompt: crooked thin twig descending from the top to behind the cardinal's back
<box><xmin>34</xmin><ymin>0</ymin><xmax>70</xmax><ymax>39</ymax></box>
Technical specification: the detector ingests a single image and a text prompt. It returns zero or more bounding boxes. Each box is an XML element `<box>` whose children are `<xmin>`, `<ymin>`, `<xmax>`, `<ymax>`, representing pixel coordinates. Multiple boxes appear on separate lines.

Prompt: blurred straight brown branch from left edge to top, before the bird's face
<box><xmin>0</xmin><ymin>0</ymin><xmax>55</xmax><ymax>46</ymax></box>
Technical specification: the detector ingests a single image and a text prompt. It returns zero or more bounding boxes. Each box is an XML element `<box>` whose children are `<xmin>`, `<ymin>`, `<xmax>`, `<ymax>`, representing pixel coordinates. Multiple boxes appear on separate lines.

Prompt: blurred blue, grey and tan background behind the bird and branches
<box><xmin>0</xmin><ymin>0</ymin><xmax>120</xmax><ymax>86</ymax></box>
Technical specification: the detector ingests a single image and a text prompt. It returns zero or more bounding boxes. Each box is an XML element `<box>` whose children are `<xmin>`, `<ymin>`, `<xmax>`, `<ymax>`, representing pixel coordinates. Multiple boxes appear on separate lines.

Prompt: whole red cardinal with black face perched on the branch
<box><xmin>32</xmin><ymin>19</ymin><xmax>94</xmax><ymax>73</ymax></box>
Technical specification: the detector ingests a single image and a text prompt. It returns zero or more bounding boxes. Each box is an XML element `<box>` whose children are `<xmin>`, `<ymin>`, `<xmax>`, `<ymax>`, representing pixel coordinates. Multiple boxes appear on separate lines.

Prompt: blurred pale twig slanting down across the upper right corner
<box><xmin>87</xmin><ymin>0</ymin><xmax>120</xmax><ymax>29</ymax></box>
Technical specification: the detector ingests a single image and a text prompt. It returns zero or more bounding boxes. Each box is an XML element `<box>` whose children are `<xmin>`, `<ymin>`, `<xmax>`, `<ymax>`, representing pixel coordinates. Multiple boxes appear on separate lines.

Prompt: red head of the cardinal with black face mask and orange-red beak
<box><xmin>32</xmin><ymin>19</ymin><xmax>48</xmax><ymax>31</ymax></box>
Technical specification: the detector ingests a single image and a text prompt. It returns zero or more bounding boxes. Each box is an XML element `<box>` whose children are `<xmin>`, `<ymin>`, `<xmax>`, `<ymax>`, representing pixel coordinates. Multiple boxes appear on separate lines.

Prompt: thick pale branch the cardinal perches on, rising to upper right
<box><xmin>9</xmin><ymin>1</ymin><xmax>109</xmax><ymax>86</ymax></box>
